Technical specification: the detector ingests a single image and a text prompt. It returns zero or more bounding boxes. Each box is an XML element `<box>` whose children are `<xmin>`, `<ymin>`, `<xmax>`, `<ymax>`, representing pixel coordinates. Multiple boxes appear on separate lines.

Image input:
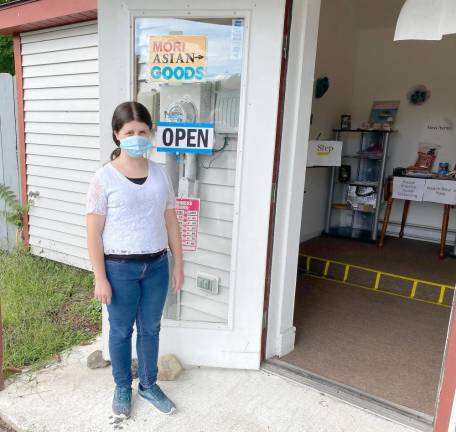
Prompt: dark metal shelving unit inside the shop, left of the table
<box><xmin>325</xmin><ymin>129</ymin><xmax>394</xmax><ymax>241</ymax></box>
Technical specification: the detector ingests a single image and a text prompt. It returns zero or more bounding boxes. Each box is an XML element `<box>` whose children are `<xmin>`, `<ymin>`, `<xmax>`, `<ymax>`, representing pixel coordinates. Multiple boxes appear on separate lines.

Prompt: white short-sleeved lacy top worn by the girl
<box><xmin>86</xmin><ymin>160</ymin><xmax>175</xmax><ymax>255</ymax></box>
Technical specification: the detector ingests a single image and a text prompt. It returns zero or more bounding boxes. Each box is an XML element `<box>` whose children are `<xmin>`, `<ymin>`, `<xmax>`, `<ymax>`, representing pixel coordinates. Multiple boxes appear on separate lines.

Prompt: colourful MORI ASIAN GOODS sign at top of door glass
<box><xmin>149</xmin><ymin>35</ymin><xmax>207</xmax><ymax>82</ymax></box>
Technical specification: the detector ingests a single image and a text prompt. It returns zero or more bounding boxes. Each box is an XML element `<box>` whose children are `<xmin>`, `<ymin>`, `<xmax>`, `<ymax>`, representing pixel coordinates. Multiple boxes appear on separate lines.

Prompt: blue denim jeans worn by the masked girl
<box><xmin>105</xmin><ymin>254</ymin><xmax>169</xmax><ymax>388</ymax></box>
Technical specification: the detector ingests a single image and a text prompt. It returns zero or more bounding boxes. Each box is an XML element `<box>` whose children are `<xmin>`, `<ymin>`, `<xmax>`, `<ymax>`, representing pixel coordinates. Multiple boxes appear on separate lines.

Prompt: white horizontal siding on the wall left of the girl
<box><xmin>21</xmin><ymin>22</ymin><xmax>100</xmax><ymax>268</ymax></box>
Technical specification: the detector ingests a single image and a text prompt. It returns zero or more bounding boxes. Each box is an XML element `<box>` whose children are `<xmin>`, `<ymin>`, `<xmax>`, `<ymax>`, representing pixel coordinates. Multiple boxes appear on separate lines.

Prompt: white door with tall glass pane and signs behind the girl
<box><xmin>98</xmin><ymin>0</ymin><xmax>285</xmax><ymax>368</ymax></box>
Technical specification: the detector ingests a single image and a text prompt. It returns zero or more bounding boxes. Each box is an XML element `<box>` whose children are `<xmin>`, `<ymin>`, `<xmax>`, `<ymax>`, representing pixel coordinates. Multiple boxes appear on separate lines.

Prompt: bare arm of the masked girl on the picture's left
<box><xmin>86</xmin><ymin>213</ymin><xmax>112</xmax><ymax>304</ymax></box>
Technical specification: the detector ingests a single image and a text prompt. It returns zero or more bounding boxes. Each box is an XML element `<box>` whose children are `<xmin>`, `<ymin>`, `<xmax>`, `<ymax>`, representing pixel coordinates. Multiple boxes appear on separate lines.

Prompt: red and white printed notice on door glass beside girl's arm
<box><xmin>176</xmin><ymin>198</ymin><xmax>200</xmax><ymax>251</ymax></box>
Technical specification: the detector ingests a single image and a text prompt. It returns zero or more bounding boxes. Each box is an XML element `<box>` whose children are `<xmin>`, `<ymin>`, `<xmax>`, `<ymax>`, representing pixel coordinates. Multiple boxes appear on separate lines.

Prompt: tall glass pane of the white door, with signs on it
<box><xmin>134</xmin><ymin>17</ymin><xmax>245</xmax><ymax>323</ymax></box>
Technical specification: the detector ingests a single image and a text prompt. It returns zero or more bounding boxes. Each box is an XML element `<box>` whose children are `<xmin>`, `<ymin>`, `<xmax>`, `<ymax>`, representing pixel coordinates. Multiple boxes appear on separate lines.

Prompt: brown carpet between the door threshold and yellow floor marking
<box><xmin>282</xmin><ymin>275</ymin><xmax>450</xmax><ymax>416</ymax></box>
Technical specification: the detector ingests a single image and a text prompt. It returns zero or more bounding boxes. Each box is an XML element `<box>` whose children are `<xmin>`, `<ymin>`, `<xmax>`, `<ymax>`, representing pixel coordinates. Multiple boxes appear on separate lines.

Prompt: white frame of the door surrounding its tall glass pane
<box><xmin>98</xmin><ymin>0</ymin><xmax>285</xmax><ymax>369</ymax></box>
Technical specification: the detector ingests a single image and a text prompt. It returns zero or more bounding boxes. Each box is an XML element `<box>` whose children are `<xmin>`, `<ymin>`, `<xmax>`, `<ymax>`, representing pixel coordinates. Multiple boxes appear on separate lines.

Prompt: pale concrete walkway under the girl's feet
<box><xmin>0</xmin><ymin>340</ymin><xmax>420</xmax><ymax>432</ymax></box>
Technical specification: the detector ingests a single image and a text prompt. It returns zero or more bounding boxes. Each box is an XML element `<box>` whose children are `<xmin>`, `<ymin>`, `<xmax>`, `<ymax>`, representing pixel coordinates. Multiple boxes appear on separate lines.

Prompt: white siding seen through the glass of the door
<box><xmin>138</xmin><ymin>86</ymin><xmax>237</xmax><ymax>323</ymax></box>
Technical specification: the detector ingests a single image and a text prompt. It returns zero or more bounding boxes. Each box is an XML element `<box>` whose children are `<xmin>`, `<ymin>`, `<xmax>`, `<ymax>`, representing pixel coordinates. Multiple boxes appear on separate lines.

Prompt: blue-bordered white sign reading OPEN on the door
<box><xmin>157</xmin><ymin>122</ymin><xmax>214</xmax><ymax>154</ymax></box>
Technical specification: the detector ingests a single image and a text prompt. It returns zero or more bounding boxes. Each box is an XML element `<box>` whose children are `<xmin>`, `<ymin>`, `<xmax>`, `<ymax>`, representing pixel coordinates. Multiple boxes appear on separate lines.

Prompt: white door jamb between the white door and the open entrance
<box><xmin>262</xmin><ymin>0</ymin><xmax>321</xmax><ymax>360</ymax></box>
